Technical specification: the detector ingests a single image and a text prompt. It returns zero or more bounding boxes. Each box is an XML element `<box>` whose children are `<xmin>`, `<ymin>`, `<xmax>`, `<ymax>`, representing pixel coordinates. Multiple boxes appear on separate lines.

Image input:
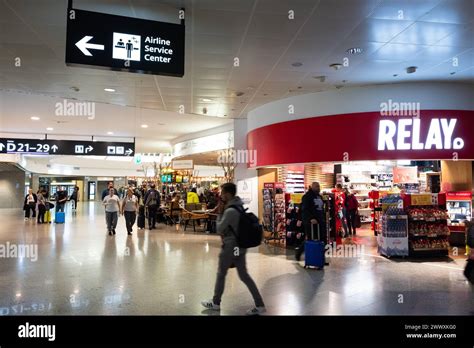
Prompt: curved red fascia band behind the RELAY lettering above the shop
<box><xmin>247</xmin><ymin>110</ymin><xmax>474</xmax><ymax>167</ymax></box>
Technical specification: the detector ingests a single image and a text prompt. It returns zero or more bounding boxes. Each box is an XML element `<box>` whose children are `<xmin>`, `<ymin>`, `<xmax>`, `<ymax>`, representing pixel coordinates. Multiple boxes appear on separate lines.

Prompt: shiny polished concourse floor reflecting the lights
<box><xmin>0</xmin><ymin>203</ymin><xmax>474</xmax><ymax>315</ymax></box>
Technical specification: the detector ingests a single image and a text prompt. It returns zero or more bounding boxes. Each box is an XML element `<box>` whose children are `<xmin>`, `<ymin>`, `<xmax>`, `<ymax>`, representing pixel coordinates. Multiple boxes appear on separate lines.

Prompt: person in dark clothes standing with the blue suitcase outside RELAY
<box><xmin>295</xmin><ymin>182</ymin><xmax>327</xmax><ymax>261</ymax></box>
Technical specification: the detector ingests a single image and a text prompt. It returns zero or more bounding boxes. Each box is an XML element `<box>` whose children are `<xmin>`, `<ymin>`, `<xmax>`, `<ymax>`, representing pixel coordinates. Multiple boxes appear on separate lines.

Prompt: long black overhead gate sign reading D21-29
<box><xmin>0</xmin><ymin>138</ymin><xmax>135</xmax><ymax>156</ymax></box>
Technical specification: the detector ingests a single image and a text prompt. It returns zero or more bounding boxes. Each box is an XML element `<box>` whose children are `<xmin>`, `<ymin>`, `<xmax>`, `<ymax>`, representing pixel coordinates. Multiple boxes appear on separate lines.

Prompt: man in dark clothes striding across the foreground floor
<box><xmin>201</xmin><ymin>183</ymin><xmax>266</xmax><ymax>315</ymax></box>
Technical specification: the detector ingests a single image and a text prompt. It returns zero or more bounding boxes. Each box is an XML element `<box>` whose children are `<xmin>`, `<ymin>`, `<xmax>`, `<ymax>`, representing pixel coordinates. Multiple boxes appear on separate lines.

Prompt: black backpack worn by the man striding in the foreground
<box><xmin>229</xmin><ymin>205</ymin><xmax>263</xmax><ymax>249</ymax></box>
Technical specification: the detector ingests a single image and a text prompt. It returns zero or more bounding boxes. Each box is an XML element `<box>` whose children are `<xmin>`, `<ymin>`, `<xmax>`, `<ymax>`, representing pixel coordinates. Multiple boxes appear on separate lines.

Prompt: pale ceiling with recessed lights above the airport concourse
<box><xmin>0</xmin><ymin>0</ymin><xmax>474</xmax><ymax>151</ymax></box>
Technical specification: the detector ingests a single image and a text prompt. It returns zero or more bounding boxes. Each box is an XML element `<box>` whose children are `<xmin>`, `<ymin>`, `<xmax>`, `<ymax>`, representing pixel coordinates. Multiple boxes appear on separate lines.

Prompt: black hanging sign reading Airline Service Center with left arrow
<box><xmin>66</xmin><ymin>9</ymin><xmax>184</xmax><ymax>77</ymax></box>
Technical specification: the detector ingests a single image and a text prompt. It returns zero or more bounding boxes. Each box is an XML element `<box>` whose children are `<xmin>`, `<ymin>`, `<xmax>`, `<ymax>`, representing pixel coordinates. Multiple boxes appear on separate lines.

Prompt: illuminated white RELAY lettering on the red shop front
<box><xmin>378</xmin><ymin>118</ymin><xmax>464</xmax><ymax>151</ymax></box>
